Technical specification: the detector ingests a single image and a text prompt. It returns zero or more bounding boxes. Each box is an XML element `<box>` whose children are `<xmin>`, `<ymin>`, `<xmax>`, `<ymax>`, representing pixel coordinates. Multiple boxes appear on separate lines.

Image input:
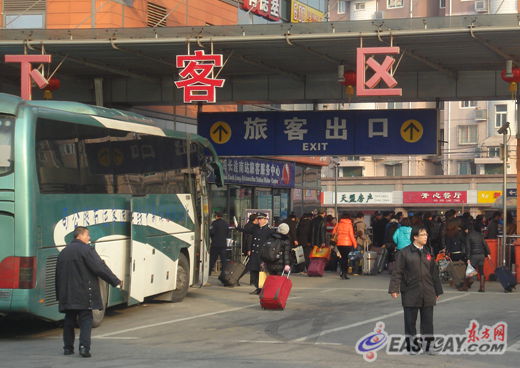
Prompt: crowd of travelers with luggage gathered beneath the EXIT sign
<box><xmin>210</xmin><ymin>209</ymin><xmax>516</xmax><ymax>294</ymax></box>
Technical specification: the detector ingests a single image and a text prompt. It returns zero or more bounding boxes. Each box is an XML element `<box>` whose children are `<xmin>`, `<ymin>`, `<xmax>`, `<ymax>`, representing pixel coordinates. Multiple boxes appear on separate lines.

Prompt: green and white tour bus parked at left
<box><xmin>0</xmin><ymin>94</ymin><xmax>223</xmax><ymax>325</ymax></box>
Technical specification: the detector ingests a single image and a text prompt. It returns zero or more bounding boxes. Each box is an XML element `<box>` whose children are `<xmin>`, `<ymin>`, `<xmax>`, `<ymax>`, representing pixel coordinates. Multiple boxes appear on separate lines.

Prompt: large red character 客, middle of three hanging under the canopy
<box><xmin>175</xmin><ymin>50</ymin><xmax>225</xmax><ymax>103</ymax></box>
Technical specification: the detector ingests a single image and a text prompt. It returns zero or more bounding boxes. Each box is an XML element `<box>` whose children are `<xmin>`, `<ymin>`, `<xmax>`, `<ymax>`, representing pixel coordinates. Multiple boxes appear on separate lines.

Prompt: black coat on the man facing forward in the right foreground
<box><xmin>388</xmin><ymin>244</ymin><xmax>443</xmax><ymax>307</ymax></box>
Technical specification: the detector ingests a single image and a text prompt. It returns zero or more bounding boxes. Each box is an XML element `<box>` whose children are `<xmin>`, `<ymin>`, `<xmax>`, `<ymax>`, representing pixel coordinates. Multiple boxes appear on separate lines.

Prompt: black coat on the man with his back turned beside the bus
<box><xmin>55</xmin><ymin>239</ymin><xmax>121</xmax><ymax>313</ymax></box>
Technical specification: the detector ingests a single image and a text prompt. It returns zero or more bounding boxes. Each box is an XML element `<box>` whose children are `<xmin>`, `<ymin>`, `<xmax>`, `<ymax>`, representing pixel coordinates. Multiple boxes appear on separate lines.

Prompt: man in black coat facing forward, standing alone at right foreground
<box><xmin>388</xmin><ymin>226</ymin><xmax>443</xmax><ymax>353</ymax></box>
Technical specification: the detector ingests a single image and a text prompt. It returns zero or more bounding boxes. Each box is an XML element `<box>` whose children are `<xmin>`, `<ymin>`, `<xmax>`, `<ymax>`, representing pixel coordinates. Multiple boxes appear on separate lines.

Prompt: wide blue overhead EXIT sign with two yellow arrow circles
<box><xmin>198</xmin><ymin>109</ymin><xmax>438</xmax><ymax>156</ymax></box>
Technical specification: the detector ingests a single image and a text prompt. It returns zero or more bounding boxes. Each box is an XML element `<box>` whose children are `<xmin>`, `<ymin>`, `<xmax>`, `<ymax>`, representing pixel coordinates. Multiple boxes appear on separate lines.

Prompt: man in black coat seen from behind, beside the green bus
<box><xmin>56</xmin><ymin>226</ymin><xmax>122</xmax><ymax>358</ymax></box>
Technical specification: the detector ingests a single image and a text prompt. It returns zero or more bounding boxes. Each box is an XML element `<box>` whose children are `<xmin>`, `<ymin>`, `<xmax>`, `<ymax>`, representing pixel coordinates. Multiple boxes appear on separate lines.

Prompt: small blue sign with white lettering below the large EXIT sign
<box><xmin>221</xmin><ymin>158</ymin><xmax>295</xmax><ymax>188</ymax></box>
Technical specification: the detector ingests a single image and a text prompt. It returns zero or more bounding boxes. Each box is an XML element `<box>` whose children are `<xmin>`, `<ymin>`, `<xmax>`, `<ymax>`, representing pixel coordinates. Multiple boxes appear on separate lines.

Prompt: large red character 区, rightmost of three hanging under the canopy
<box><xmin>356</xmin><ymin>47</ymin><xmax>402</xmax><ymax>96</ymax></box>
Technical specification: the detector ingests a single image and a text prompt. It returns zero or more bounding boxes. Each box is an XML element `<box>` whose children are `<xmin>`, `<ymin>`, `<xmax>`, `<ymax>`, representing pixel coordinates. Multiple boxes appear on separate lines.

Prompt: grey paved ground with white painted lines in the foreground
<box><xmin>0</xmin><ymin>273</ymin><xmax>520</xmax><ymax>368</ymax></box>
